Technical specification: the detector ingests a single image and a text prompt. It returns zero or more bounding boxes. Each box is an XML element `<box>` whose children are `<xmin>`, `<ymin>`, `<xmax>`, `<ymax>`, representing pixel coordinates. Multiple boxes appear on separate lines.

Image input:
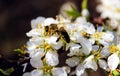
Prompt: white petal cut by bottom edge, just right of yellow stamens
<box><xmin>52</xmin><ymin>68</ymin><xmax>67</xmax><ymax>76</ymax></box>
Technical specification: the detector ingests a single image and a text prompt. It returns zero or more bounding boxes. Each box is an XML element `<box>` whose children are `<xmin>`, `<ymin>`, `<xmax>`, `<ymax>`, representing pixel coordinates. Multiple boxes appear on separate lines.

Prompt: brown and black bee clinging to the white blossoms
<box><xmin>45</xmin><ymin>24</ymin><xmax>70</xmax><ymax>43</ymax></box>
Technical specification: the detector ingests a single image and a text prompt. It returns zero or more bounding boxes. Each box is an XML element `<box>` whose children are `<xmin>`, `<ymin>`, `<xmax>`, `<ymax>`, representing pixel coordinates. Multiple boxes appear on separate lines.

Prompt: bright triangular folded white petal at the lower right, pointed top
<box><xmin>83</xmin><ymin>55</ymin><xmax>98</xmax><ymax>71</ymax></box>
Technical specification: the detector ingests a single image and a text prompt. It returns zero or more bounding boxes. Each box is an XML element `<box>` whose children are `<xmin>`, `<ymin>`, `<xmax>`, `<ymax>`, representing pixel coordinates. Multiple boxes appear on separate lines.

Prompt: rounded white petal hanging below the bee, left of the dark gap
<box><xmin>45</xmin><ymin>51</ymin><xmax>59</xmax><ymax>66</ymax></box>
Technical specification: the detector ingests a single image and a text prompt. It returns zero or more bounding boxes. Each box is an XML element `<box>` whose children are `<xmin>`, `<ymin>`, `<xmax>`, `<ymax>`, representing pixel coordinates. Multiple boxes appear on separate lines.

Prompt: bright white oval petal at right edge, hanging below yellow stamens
<box><xmin>108</xmin><ymin>53</ymin><xmax>120</xmax><ymax>70</ymax></box>
